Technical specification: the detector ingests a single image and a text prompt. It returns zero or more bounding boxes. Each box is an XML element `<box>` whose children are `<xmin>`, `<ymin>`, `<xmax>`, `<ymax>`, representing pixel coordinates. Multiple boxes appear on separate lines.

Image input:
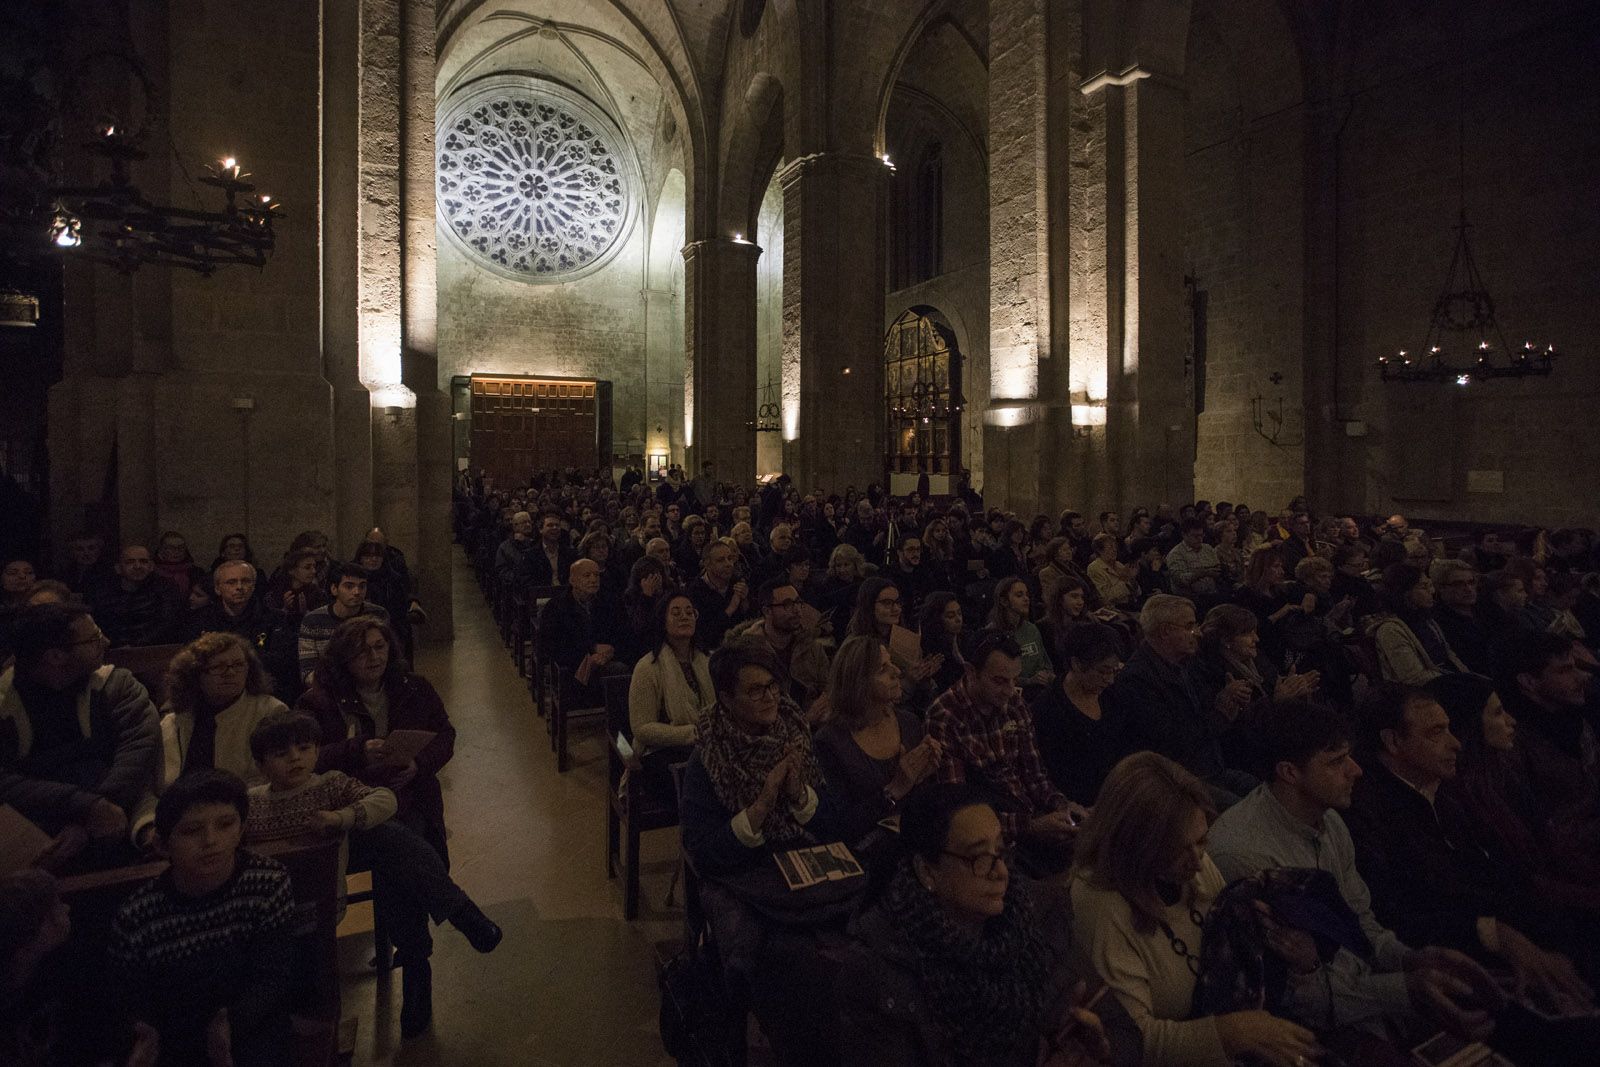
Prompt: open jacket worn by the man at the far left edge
<box><xmin>0</xmin><ymin>665</ymin><xmax>162</xmax><ymax>833</ymax></box>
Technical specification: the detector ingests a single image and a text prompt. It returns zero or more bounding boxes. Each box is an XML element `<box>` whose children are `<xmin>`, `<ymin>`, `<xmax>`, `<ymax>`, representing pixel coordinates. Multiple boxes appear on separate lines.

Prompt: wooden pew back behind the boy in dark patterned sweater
<box><xmin>61</xmin><ymin>838</ymin><xmax>339</xmax><ymax>1067</ymax></box>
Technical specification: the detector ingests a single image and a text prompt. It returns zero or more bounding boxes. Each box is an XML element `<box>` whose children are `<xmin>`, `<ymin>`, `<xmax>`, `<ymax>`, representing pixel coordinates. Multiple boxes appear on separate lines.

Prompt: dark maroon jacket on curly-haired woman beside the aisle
<box><xmin>294</xmin><ymin>673</ymin><xmax>456</xmax><ymax>838</ymax></box>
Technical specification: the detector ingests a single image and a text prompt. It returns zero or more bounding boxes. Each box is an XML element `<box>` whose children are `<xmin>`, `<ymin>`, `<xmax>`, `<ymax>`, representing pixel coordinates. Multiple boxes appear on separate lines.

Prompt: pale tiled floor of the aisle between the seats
<box><xmin>339</xmin><ymin>549</ymin><xmax>682</xmax><ymax>1067</ymax></box>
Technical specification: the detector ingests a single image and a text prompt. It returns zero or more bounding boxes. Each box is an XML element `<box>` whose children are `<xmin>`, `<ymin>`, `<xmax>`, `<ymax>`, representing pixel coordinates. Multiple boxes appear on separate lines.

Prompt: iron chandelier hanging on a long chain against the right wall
<box><xmin>1378</xmin><ymin>47</ymin><xmax>1560</xmax><ymax>386</ymax></box>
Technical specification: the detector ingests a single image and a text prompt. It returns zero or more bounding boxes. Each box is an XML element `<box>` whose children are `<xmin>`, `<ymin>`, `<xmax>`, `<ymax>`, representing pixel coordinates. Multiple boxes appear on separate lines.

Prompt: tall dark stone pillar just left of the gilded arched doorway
<box><xmin>778</xmin><ymin>152</ymin><xmax>888</xmax><ymax>493</ymax></box>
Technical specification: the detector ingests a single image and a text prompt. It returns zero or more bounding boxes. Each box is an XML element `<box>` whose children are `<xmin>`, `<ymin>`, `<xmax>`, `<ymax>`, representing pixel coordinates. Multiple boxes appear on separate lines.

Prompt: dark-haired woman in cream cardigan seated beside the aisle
<box><xmin>627</xmin><ymin>592</ymin><xmax>714</xmax><ymax>797</ymax></box>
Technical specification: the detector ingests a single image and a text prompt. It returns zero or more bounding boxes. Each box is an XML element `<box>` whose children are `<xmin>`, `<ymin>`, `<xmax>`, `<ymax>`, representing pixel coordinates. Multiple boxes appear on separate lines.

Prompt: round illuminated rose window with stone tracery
<box><xmin>437</xmin><ymin>77</ymin><xmax>632</xmax><ymax>282</ymax></box>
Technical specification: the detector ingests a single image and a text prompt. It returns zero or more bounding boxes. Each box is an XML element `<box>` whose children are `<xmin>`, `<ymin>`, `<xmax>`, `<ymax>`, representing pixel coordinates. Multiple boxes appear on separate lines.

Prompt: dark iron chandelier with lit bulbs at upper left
<box><xmin>46</xmin><ymin>53</ymin><xmax>283</xmax><ymax>275</ymax></box>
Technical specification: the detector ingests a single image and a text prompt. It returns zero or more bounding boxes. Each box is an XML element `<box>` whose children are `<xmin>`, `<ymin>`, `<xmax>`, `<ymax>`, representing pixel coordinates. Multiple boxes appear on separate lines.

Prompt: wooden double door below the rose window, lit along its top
<box><xmin>470</xmin><ymin>374</ymin><xmax>602</xmax><ymax>486</ymax></box>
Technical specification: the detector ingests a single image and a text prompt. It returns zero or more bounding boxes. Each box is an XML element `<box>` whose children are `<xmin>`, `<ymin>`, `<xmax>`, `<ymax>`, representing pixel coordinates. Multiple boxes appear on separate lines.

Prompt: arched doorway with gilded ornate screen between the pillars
<box><xmin>883</xmin><ymin>307</ymin><xmax>963</xmax><ymax>494</ymax></box>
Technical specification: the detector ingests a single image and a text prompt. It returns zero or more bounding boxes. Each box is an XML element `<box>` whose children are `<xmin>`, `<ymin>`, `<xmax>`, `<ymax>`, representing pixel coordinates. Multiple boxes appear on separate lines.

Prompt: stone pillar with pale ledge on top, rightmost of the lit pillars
<box><xmin>1074</xmin><ymin>67</ymin><xmax>1194</xmax><ymax>514</ymax></box>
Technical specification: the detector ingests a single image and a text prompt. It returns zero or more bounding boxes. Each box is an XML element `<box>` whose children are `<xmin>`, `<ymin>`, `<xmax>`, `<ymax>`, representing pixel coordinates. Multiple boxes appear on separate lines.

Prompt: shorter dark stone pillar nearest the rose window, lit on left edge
<box><xmin>683</xmin><ymin>237</ymin><xmax>761</xmax><ymax>485</ymax></box>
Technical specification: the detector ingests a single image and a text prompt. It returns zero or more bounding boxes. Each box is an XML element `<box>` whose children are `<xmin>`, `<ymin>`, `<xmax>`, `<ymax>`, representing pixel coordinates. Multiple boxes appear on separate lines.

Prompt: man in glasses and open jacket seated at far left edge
<box><xmin>0</xmin><ymin>603</ymin><xmax>160</xmax><ymax>865</ymax></box>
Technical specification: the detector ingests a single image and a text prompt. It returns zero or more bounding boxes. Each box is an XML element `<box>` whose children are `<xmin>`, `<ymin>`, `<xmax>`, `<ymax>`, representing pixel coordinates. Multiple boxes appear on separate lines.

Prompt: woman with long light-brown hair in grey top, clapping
<box><xmin>814</xmin><ymin>637</ymin><xmax>941</xmax><ymax>846</ymax></box>
